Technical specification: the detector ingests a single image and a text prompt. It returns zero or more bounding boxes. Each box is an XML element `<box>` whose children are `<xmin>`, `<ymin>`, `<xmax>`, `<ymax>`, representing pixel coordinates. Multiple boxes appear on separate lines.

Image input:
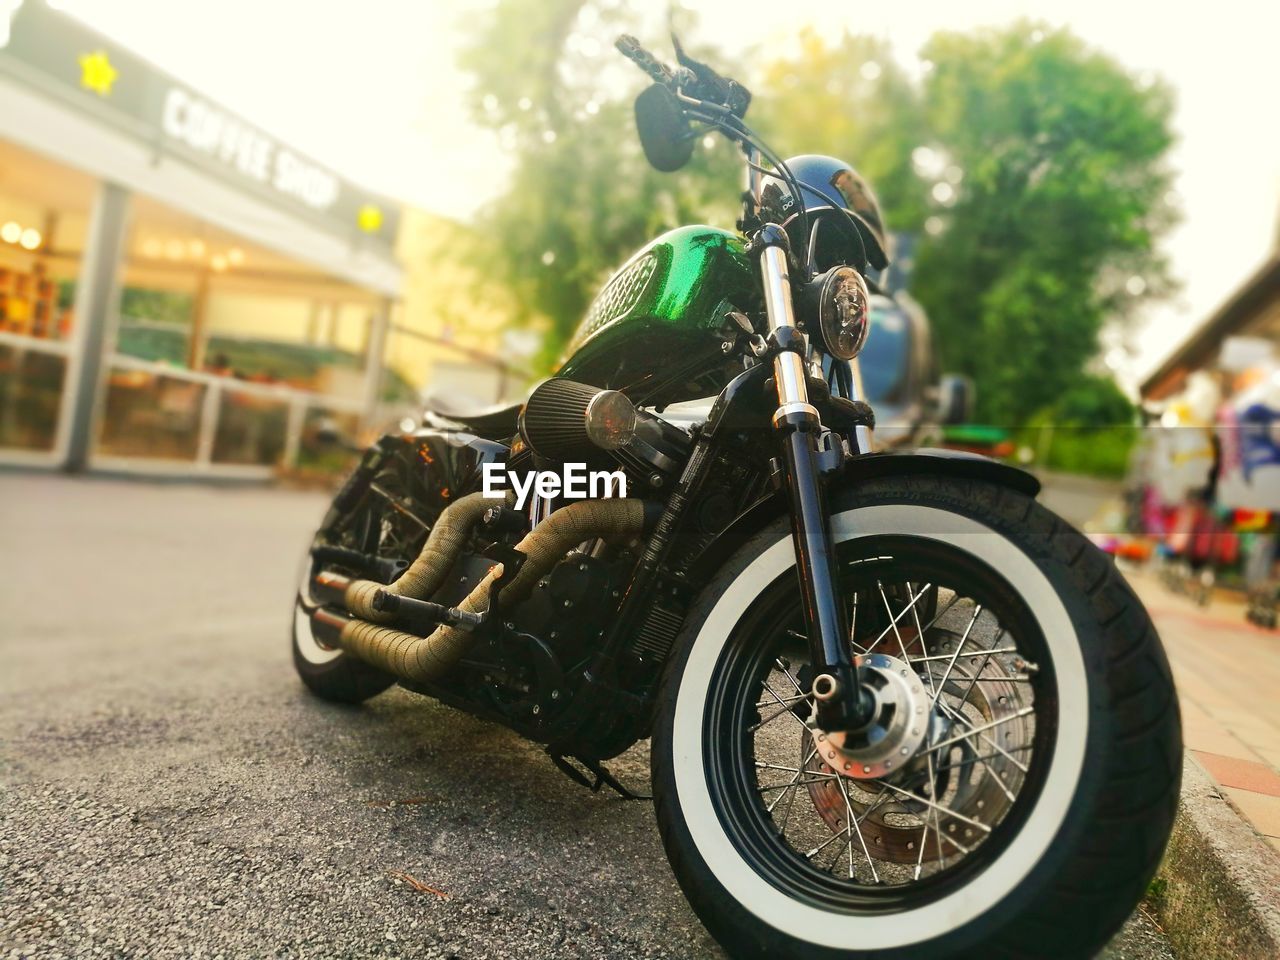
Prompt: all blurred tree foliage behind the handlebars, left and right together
<box><xmin>462</xmin><ymin>10</ymin><xmax>1171</xmax><ymax>425</ymax></box>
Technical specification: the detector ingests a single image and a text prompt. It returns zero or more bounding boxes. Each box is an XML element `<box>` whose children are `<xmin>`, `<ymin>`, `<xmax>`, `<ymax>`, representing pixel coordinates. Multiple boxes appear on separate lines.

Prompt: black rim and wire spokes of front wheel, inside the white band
<box><xmin>704</xmin><ymin>538</ymin><xmax>1057</xmax><ymax>914</ymax></box>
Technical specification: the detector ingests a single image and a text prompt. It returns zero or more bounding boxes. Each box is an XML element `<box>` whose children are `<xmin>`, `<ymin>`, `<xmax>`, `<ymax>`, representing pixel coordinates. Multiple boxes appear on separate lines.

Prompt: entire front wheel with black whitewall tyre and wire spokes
<box><xmin>652</xmin><ymin>477</ymin><xmax>1181</xmax><ymax>960</ymax></box>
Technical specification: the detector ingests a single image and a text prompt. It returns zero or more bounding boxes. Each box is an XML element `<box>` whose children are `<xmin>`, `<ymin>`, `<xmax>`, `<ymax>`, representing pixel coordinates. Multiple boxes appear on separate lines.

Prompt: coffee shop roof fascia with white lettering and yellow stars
<box><xmin>0</xmin><ymin>1</ymin><xmax>402</xmax><ymax>297</ymax></box>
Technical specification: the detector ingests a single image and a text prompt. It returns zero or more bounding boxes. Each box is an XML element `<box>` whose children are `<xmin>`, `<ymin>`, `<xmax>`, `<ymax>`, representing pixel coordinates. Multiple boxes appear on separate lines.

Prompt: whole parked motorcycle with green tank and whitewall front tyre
<box><xmin>292</xmin><ymin>37</ymin><xmax>1181</xmax><ymax>959</ymax></box>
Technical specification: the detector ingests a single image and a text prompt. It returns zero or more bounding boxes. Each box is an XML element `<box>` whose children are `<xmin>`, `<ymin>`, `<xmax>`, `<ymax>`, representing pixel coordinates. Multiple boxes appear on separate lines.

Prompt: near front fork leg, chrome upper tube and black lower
<box><xmin>754</xmin><ymin>224</ymin><xmax>874</xmax><ymax>731</ymax></box>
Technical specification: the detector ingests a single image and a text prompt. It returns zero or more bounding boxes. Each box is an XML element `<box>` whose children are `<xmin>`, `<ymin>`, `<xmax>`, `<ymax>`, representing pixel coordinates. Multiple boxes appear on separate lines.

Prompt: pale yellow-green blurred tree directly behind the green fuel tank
<box><xmin>461</xmin><ymin>0</ymin><xmax>740</xmax><ymax>364</ymax></box>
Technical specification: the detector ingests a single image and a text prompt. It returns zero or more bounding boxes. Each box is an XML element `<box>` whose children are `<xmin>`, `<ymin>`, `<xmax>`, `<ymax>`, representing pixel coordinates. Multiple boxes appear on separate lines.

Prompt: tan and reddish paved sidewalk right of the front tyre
<box><xmin>1128</xmin><ymin>572</ymin><xmax>1280</xmax><ymax>851</ymax></box>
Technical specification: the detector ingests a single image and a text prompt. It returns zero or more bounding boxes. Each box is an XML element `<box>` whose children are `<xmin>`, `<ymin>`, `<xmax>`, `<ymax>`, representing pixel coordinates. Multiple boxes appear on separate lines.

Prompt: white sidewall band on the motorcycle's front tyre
<box><xmin>666</xmin><ymin>503</ymin><xmax>1089</xmax><ymax>950</ymax></box>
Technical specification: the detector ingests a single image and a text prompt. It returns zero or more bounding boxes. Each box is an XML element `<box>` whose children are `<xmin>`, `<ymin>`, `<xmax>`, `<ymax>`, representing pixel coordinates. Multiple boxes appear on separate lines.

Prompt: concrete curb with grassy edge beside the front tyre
<box><xmin>1148</xmin><ymin>754</ymin><xmax>1280</xmax><ymax>960</ymax></box>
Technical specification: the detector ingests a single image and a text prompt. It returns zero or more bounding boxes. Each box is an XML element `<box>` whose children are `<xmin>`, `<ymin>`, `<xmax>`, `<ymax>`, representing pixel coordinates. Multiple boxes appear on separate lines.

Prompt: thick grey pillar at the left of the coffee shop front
<box><xmin>63</xmin><ymin>183</ymin><xmax>129</xmax><ymax>472</ymax></box>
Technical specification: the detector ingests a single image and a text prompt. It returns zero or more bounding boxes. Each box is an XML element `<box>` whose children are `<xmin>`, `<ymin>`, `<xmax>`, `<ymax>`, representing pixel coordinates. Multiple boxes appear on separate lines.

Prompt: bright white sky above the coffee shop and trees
<box><xmin>52</xmin><ymin>0</ymin><xmax>1280</xmax><ymax>383</ymax></box>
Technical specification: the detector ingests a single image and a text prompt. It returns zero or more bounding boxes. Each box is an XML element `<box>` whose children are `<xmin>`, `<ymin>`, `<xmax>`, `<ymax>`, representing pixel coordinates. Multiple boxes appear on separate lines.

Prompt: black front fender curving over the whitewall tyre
<box><xmin>687</xmin><ymin>447</ymin><xmax>1041</xmax><ymax>582</ymax></box>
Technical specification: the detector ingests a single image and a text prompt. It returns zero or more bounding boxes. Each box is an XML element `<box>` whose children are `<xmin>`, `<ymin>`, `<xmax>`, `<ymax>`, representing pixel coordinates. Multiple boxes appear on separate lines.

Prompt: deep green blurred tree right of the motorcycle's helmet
<box><xmin>913</xmin><ymin>23</ymin><xmax>1172</xmax><ymax>425</ymax></box>
